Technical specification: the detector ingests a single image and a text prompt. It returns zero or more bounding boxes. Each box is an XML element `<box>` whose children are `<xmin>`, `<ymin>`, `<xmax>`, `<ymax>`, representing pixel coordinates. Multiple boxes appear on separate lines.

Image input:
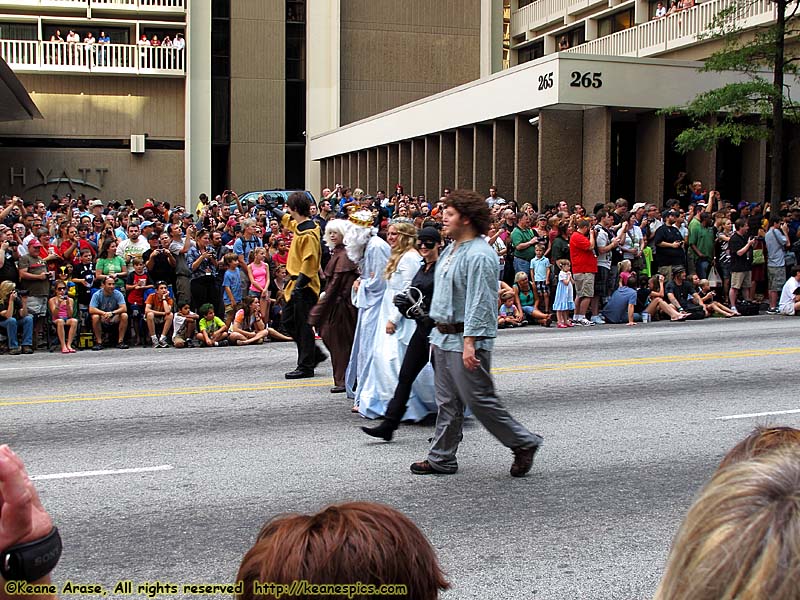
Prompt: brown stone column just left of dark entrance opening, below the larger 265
<box><xmin>580</xmin><ymin>107</ymin><xmax>612</xmax><ymax>206</ymax></box>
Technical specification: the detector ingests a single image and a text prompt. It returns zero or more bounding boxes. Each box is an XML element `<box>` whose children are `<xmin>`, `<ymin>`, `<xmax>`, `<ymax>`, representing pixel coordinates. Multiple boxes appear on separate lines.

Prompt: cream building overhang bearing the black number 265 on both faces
<box><xmin>309</xmin><ymin>53</ymin><xmax>800</xmax><ymax>160</ymax></box>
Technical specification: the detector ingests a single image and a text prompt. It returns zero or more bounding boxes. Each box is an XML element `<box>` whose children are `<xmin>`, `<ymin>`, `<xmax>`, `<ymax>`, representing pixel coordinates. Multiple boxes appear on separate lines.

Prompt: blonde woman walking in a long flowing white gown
<box><xmin>356</xmin><ymin>222</ymin><xmax>437</xmax><ymax>421</ymax></box>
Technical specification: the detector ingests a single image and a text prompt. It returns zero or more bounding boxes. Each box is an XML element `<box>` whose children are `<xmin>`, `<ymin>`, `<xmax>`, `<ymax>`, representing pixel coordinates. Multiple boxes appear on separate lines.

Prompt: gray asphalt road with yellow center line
<box><xmin>0</xmin><ymin>317</ymin><xmax>800</xmax><ymax>600</ymax></box>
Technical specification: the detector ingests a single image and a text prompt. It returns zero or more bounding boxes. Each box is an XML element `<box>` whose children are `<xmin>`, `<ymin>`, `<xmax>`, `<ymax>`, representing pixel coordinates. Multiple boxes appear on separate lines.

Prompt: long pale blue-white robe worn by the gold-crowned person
<box><xmin>345</xmin><ymin>235</ymin><xmax>391</xmax><ymax>399</ymax></box>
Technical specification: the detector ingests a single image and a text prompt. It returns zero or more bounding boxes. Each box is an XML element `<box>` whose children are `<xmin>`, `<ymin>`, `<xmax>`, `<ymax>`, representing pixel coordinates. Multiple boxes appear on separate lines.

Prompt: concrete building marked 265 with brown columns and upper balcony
<box><xmin>309</xmin><ymin>0</ymin><xmax>800</xmax><ymax>207</ymax></box>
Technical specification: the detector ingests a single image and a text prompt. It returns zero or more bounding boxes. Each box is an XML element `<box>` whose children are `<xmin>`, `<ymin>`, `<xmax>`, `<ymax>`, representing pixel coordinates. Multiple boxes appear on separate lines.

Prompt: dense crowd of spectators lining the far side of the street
<box><xmin>0</xmin><ymin>182</ymin><xmax>800</xmax><ymax>354</ymax></box>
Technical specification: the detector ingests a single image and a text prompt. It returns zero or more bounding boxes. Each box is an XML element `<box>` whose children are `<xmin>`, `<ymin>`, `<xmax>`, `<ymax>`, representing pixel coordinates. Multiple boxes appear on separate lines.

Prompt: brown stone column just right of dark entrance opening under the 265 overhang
<box><xmin>628</xmin><ymin>113</ymin><xmax>666</xmax><ymax>207</ymax></box>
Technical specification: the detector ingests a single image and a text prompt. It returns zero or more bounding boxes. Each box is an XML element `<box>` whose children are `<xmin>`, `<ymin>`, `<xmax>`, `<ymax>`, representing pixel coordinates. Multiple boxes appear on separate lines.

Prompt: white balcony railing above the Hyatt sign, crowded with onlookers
<box><xmin>0</xmin><ymin>40</ymin><xmax>186</xmax><ymax>76</ymax></box>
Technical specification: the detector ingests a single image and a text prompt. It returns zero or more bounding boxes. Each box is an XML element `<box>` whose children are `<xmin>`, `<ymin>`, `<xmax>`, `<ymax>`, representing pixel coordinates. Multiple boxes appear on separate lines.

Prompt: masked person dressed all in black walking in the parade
<box><xmin>361</xmin><ymin>227</ymin><xmax>442</xmax><ymax>442</ymax></box>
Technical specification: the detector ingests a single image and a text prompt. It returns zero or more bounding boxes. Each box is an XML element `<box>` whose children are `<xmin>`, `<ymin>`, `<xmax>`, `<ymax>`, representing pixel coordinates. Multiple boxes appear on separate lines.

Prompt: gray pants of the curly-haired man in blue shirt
<box><xmin>428</xmin><ymin>346</ymin><xmax>543</xmax><ymax>473</ymax></box>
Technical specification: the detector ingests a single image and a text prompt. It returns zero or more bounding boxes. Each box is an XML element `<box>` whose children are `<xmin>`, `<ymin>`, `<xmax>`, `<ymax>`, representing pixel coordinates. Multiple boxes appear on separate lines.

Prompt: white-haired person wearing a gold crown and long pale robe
<box><xmin>344</xmin><ymin>210</ymin><xmax>390</xmax><ymax>412</ymax></box>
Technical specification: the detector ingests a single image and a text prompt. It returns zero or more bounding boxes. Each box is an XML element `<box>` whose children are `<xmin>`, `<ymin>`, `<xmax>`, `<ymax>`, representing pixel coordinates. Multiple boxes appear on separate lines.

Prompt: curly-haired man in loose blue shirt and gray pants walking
<box><xmin>411</xmin><ymin>190</ymin><xmax>543</xmax><ymax>477</ymax></box>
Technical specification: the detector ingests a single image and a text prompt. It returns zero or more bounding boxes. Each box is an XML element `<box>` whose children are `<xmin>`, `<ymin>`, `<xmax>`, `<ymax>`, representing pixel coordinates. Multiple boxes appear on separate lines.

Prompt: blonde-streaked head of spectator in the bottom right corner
<box><xmin>655</xmin><ymin>447</ymin><xmax>800</xmax><ymax>600</ymax></box>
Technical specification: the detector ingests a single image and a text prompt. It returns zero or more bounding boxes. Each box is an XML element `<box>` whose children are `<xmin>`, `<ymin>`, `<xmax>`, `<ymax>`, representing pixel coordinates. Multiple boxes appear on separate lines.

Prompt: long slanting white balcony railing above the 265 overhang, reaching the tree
<box><xmin>566</xmin><ymin>0</ymin><xmax>777</xmax><ymax>57</ymax></box>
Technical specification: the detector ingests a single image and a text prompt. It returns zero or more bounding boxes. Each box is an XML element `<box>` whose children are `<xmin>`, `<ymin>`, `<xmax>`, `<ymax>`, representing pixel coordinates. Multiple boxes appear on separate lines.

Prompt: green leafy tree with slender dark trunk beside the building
<box><xmin>662</xmin><ymin>0</ymin><xmax>800</xmax><ymax>204</ymax></box>
